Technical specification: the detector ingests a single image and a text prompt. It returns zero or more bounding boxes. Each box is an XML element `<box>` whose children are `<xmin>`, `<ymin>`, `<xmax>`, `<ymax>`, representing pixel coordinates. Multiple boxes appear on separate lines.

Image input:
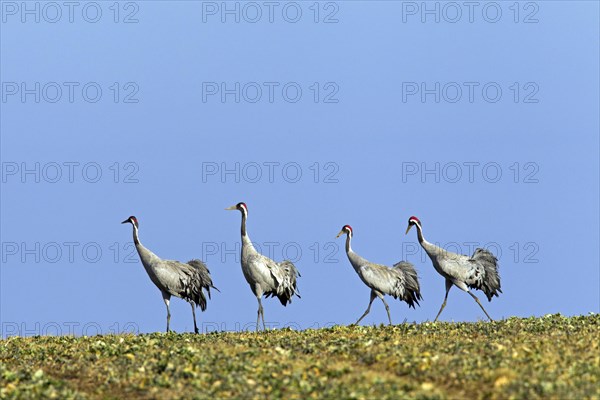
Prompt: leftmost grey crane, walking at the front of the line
<box><xmin>122</xmin><ymin>216</ymin><xmax>219</xmax><ymax>333</ymax></box>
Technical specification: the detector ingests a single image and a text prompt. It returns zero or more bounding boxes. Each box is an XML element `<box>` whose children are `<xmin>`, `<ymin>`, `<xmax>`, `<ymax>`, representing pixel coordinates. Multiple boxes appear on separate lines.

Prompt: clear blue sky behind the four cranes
<box><xmin>0</xmin><ymin>1</ymin><xmax>600</xmax><ymax>336</ymax></box>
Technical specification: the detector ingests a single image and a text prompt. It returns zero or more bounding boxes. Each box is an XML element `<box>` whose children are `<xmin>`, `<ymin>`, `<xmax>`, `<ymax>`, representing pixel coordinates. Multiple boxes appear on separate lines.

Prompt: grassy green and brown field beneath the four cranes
<box><xmin>0</xmin><ymin>314</ymin><xmax>600</xmax><ymax>399</ymax></box>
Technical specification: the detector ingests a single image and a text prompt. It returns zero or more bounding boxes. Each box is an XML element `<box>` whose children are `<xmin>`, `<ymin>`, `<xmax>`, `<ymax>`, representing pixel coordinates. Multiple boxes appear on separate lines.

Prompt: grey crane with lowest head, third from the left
<box><xmin>338</xmin><ymin>225</ymin><xmax>422</xmax><ymax>325</ymax></box>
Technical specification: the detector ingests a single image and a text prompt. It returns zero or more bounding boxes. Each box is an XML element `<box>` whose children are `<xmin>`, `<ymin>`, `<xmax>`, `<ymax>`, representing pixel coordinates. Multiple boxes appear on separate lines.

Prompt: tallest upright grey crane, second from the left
<box><xmin>226</xmin><ymin>203</ymin><xmax>300</xmax><ymax>331</ymax></box>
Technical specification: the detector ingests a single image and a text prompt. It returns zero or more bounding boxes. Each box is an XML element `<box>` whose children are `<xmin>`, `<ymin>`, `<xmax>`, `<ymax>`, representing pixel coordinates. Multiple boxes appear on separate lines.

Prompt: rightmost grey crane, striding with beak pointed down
<box><xmin>406</xmin><ymin>217</ymin><xmax>502</xmax><ymax>321</ymax></box>
